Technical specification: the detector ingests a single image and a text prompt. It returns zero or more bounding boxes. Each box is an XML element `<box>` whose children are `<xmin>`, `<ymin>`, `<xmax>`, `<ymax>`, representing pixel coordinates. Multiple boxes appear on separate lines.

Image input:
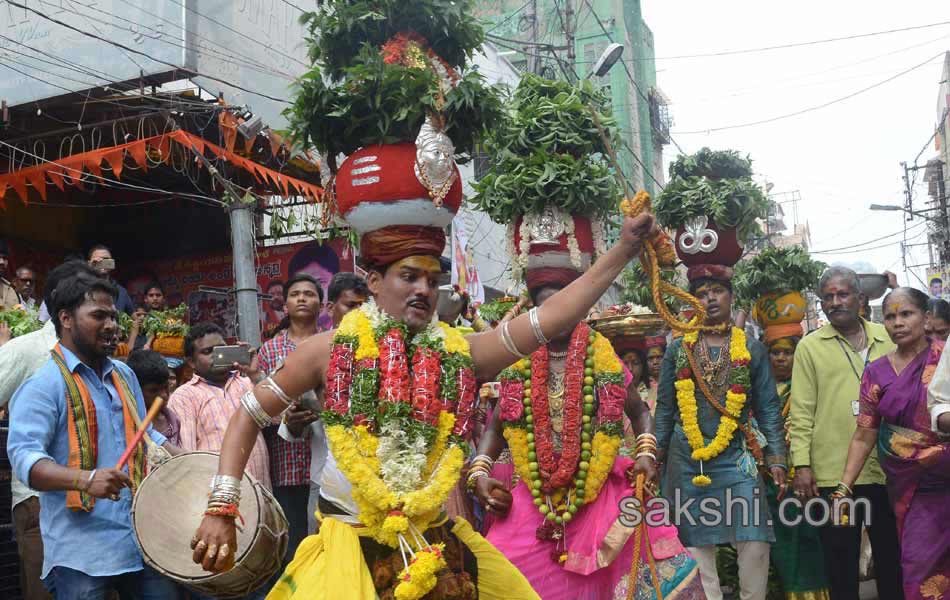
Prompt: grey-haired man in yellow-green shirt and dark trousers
<box><xmin>789</xmin><ymin>267</ymin><xmax>904</xmax><ymax>600</ymax></box>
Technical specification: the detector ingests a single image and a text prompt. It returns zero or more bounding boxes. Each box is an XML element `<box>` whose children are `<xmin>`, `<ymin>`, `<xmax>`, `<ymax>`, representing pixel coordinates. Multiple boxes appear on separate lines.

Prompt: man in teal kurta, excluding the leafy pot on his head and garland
<box><xmin>656</xmin><ymin>272</ymin><xmax>786</xmax><ymax>600</ymax></box>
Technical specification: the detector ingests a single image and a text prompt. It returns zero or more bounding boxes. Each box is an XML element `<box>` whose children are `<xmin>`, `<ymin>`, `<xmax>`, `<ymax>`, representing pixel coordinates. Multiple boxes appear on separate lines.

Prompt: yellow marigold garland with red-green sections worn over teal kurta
<box><xmin>673</xmin><ymin>327</ymin><xmax>752</xmax><ymax>487</ymax></box>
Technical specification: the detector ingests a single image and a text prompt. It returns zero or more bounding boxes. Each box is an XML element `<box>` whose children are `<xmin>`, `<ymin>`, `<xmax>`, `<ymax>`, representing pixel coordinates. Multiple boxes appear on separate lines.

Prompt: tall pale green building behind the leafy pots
<box><xmin>476</xmin><ymin>0</ymin><xmax>663</xmax><ymax>194</ymax></box>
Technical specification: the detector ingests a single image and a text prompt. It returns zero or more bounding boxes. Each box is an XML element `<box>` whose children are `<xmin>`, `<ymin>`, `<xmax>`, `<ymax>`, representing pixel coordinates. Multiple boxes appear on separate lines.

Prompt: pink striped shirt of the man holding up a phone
<box><xmin>168</xmin><ymin>373</ymin><xmax>271</xmax><ymax>489</ymax></box>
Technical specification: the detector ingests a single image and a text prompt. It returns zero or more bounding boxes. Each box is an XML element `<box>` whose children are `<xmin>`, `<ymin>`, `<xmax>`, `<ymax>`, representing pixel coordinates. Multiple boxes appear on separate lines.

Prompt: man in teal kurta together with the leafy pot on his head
<box><xmin>656</xmin><ymin>149</ymin><xmax>786</xmax><ymax>600</ymax></box>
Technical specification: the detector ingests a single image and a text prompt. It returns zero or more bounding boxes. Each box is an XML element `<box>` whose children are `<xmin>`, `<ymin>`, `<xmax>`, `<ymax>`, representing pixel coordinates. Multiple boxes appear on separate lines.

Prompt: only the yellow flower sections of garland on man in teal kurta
<box><xmin>673</xmin><ymin>327</ymin><xmax>752</xmax><ymax>487</ymax></box>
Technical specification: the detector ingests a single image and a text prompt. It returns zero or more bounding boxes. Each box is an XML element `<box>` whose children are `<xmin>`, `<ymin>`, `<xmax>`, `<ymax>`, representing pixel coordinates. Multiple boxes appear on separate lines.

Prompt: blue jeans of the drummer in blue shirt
<box><xmin>43</xmin><ymin>566</ymin><xmax>178</xmax><ymax>600</ymax></box>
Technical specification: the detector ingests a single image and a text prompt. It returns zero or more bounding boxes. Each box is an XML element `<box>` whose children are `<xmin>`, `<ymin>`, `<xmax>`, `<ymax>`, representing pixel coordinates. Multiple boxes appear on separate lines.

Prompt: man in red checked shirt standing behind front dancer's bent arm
<box><xmin>257</xmin><ymin>273</ymin><xmax>327</xmax><ymax>562</ymax></box>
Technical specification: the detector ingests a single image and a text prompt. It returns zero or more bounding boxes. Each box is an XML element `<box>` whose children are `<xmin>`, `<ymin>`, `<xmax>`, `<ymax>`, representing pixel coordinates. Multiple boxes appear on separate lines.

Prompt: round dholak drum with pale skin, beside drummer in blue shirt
<box><xmin>132</xmin><ymin>452</ymin><xmax>287</xmax><ymax>598</ymax></box>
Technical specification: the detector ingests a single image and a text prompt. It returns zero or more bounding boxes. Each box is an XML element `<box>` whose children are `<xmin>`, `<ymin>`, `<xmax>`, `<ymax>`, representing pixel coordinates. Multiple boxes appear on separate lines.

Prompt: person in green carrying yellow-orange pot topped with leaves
<box><xmin>736</xmin><ymin>247</ymin><xmax>830</xmax><ymax>600</ymax></box>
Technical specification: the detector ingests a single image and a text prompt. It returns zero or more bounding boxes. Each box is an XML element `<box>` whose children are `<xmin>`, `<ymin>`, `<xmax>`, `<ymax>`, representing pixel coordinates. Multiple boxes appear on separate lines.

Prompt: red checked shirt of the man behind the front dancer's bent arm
<box><xmin>257</xmin><ymin>329</ymin><xmax>310</xmax><ymax>487</ymax></box>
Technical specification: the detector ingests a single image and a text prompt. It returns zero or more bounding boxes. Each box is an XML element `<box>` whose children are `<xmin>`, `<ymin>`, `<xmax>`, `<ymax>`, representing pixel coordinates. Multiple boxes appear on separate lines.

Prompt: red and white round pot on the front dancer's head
<box><xmin>335</xmin><ymin>142</ymin><xmax>462</xmax><ymax>233</ymax></box>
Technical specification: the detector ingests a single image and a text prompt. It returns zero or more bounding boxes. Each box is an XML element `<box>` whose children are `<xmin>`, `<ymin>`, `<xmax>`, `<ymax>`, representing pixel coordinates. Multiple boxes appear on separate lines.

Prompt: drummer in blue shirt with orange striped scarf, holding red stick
<box><xmin>7</xmin><ymin>273</ymin><xmax>179</xmax><ymax>600</ymax></box>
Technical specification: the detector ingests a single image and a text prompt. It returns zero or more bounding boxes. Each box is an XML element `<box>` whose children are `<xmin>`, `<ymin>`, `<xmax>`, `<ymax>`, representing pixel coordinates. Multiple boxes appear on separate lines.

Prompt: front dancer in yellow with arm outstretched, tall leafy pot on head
<box><xmin>183</xmin><ymin>0</ymin><xmax>653</xmax><ymax>600</ymax></box>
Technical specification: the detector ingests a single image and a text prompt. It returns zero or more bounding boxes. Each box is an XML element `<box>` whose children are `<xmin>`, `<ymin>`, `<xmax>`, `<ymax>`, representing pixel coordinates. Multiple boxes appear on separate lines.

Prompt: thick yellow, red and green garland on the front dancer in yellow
<box><xmin>323</xmin><ymin>302</ymin><xmax>476</xmax><ymax>572</ymax></box>
